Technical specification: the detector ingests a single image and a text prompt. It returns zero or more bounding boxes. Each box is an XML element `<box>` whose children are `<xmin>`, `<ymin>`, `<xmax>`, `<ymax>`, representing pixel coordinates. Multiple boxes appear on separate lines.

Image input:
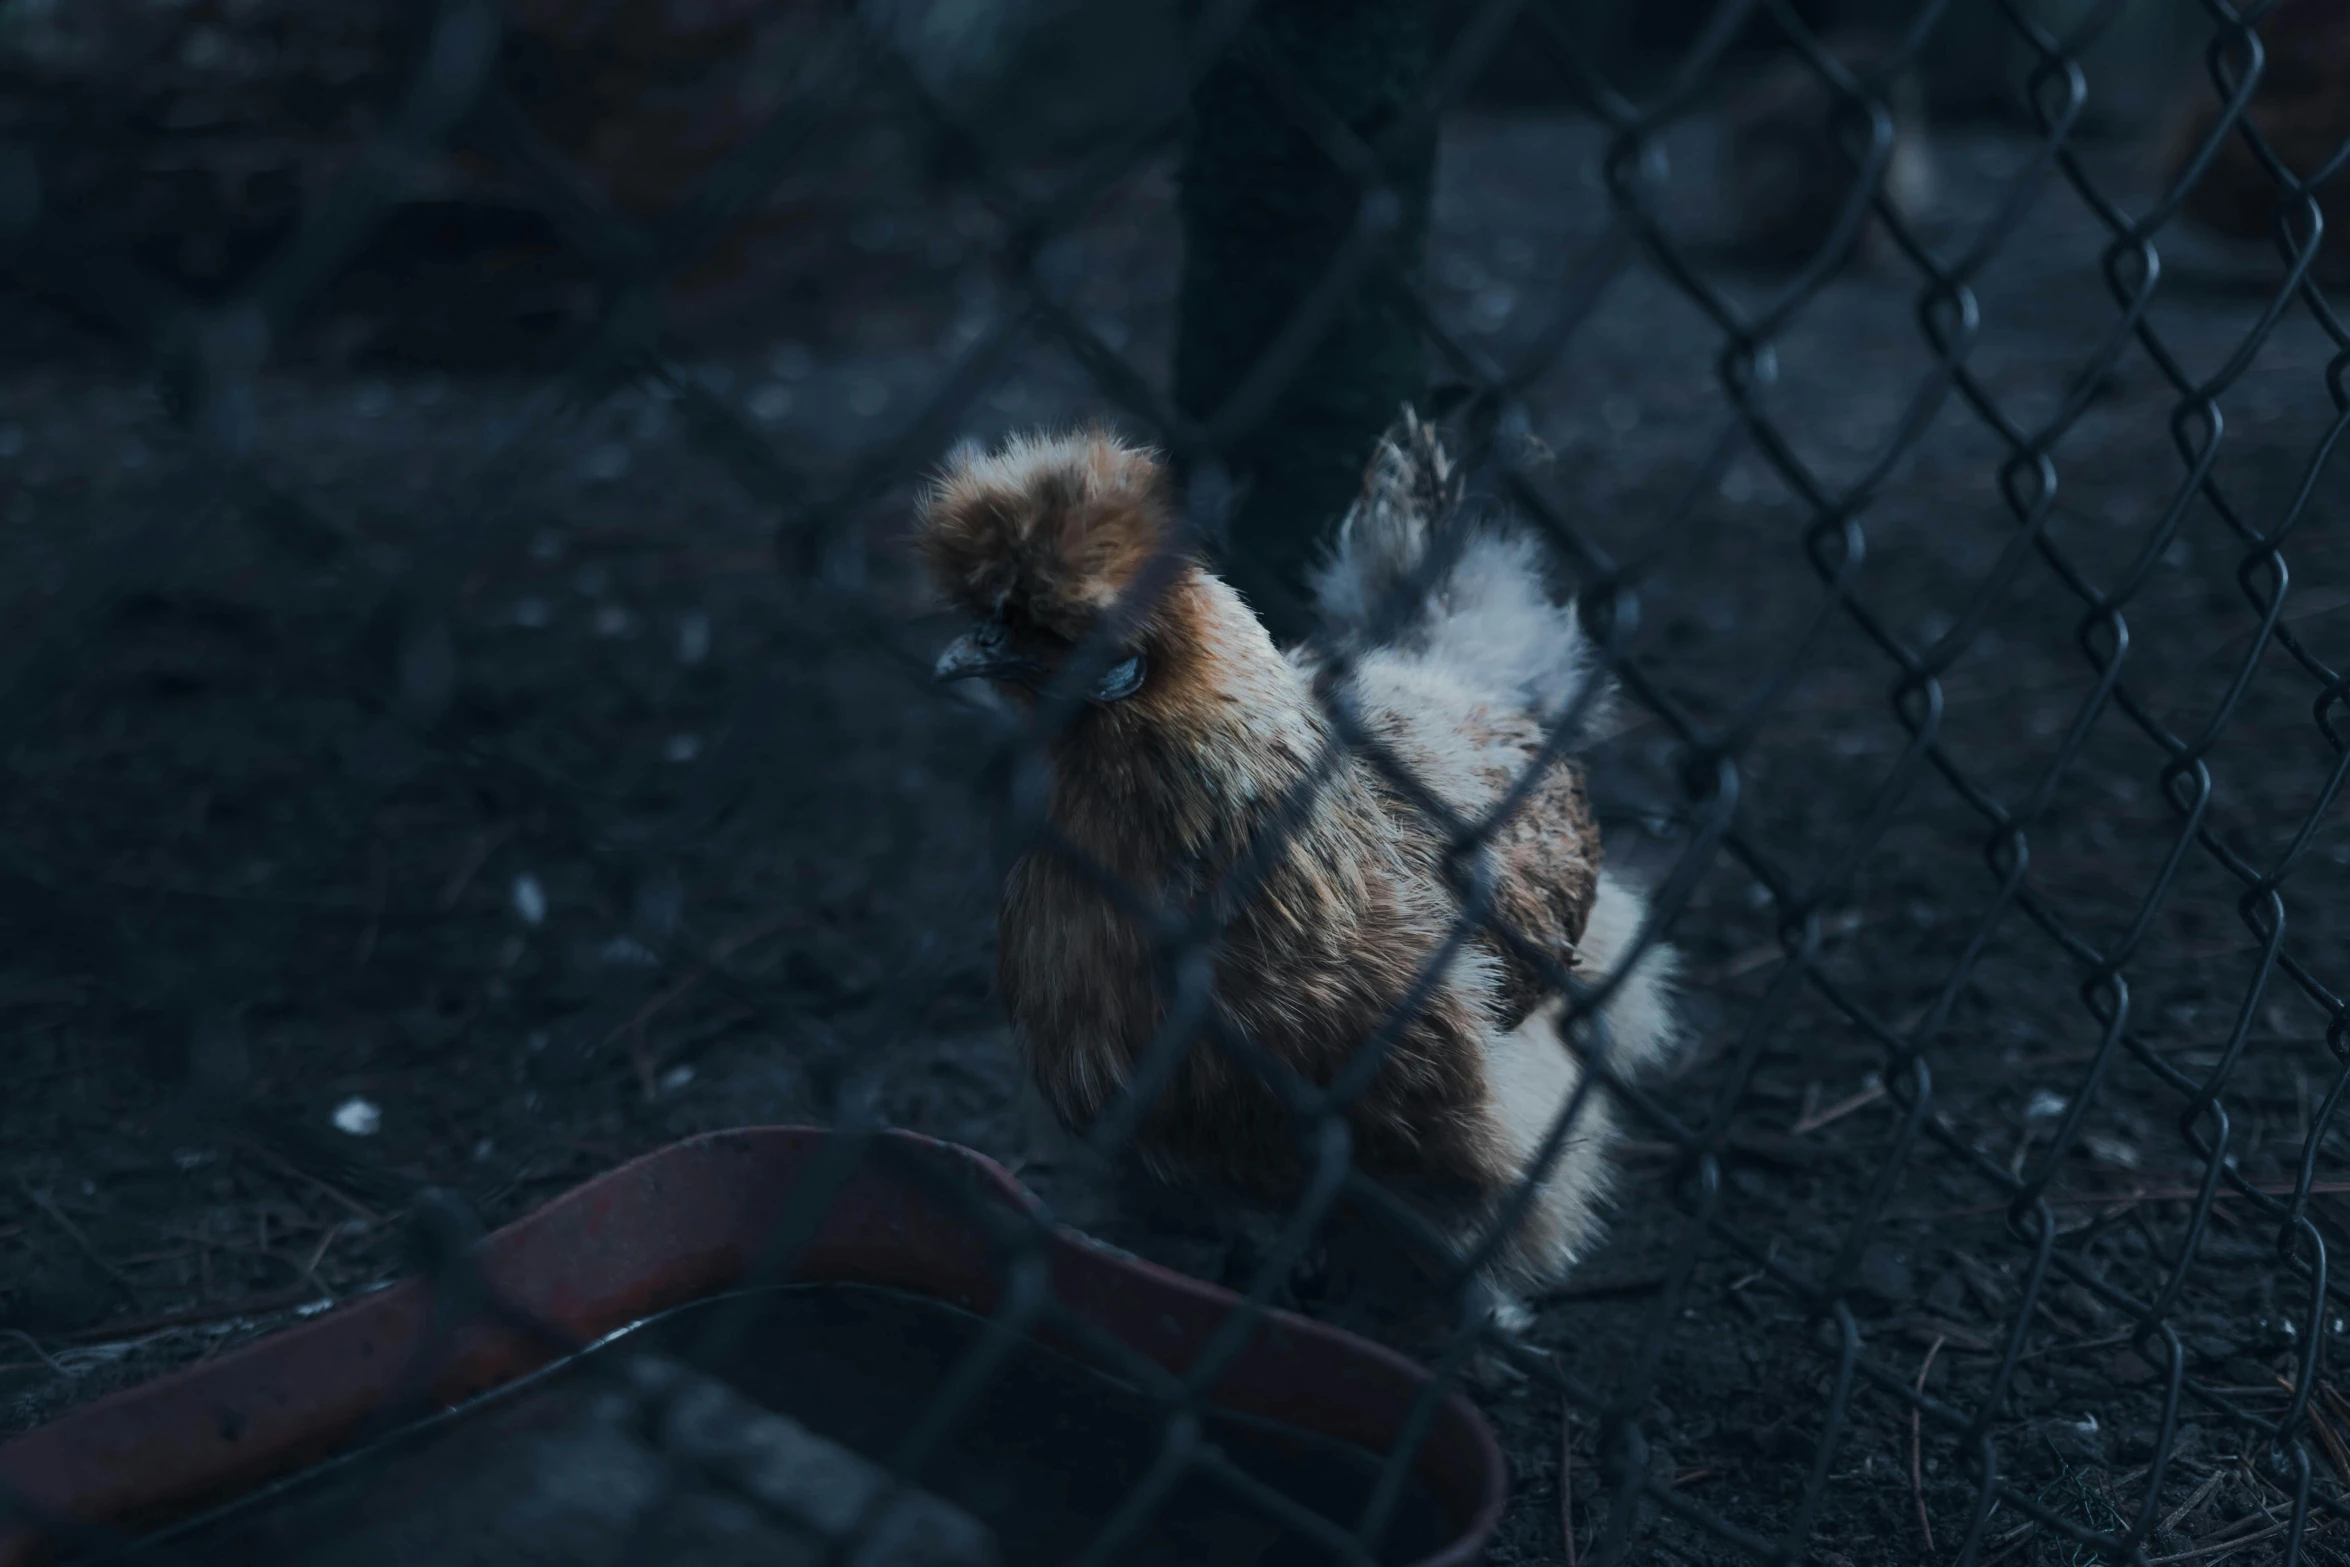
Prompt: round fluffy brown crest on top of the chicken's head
<box><xmin>914</xmin><ymin>430</ymin><xmax>1175</xmax><ymax>637</ymax></box>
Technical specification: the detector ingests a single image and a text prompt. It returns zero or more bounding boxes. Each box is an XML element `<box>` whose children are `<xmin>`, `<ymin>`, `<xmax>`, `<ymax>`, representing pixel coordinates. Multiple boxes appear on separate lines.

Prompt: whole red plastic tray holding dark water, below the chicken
<box><xmin>0</xmin><ymin>1128</ymin><xmax>1504</xmax><ymax>1567</ymax></box>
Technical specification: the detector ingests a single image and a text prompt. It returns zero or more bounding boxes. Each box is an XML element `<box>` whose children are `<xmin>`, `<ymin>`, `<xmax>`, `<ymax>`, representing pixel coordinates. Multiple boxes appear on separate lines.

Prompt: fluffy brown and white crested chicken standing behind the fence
<box><xmin>917</xmin><ymin>416</ymin><xmax>1673</xmax><ymax>1320</ymax></box>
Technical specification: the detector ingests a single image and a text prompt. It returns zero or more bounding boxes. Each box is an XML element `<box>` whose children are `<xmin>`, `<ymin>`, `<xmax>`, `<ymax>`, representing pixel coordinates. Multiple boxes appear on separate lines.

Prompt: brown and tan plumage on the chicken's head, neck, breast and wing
<box><xmin>919</xmin><ymin>422</ymin><xmax>1654</xmax><ymax>1306</ymax></box>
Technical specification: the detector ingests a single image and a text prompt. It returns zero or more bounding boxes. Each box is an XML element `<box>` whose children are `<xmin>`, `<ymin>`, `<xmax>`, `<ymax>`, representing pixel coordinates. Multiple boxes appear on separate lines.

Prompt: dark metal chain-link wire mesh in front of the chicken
<box><xmin>0</xmin><ymin>0</ymin><xmax>2350</xmax><ymax>1562</ymax></box>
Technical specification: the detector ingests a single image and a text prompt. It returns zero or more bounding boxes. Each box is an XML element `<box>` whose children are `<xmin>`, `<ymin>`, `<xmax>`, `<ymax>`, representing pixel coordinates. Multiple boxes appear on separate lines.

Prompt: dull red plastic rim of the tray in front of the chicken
<box><xmin>0</xmin><ymin>1128</ymin><xmax>1506</xmax><ymax>1567</ymax></box>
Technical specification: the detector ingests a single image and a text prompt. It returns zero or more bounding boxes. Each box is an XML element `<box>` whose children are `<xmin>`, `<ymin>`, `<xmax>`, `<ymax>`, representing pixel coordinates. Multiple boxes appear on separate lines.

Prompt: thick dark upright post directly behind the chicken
<box><xmin>1175</xmin><ymin>0</ymin><xmax>1436</xmax><ymax>641</ymax></box>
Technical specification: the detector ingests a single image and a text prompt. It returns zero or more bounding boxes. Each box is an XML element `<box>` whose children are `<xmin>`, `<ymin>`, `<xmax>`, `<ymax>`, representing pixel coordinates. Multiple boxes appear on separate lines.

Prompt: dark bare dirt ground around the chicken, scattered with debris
<box><xmin>0</xmin><ymin>103</ymin><xmax>2350</xmax><ymax>1565</ymax></box>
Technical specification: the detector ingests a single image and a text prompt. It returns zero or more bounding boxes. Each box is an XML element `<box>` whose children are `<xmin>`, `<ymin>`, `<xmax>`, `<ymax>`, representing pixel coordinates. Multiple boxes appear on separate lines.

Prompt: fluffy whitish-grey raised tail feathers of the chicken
<box><xmin>1311</xmin><ymin>409</ymin><xmax>1610</xmax><ymax>733</ymax></box>
